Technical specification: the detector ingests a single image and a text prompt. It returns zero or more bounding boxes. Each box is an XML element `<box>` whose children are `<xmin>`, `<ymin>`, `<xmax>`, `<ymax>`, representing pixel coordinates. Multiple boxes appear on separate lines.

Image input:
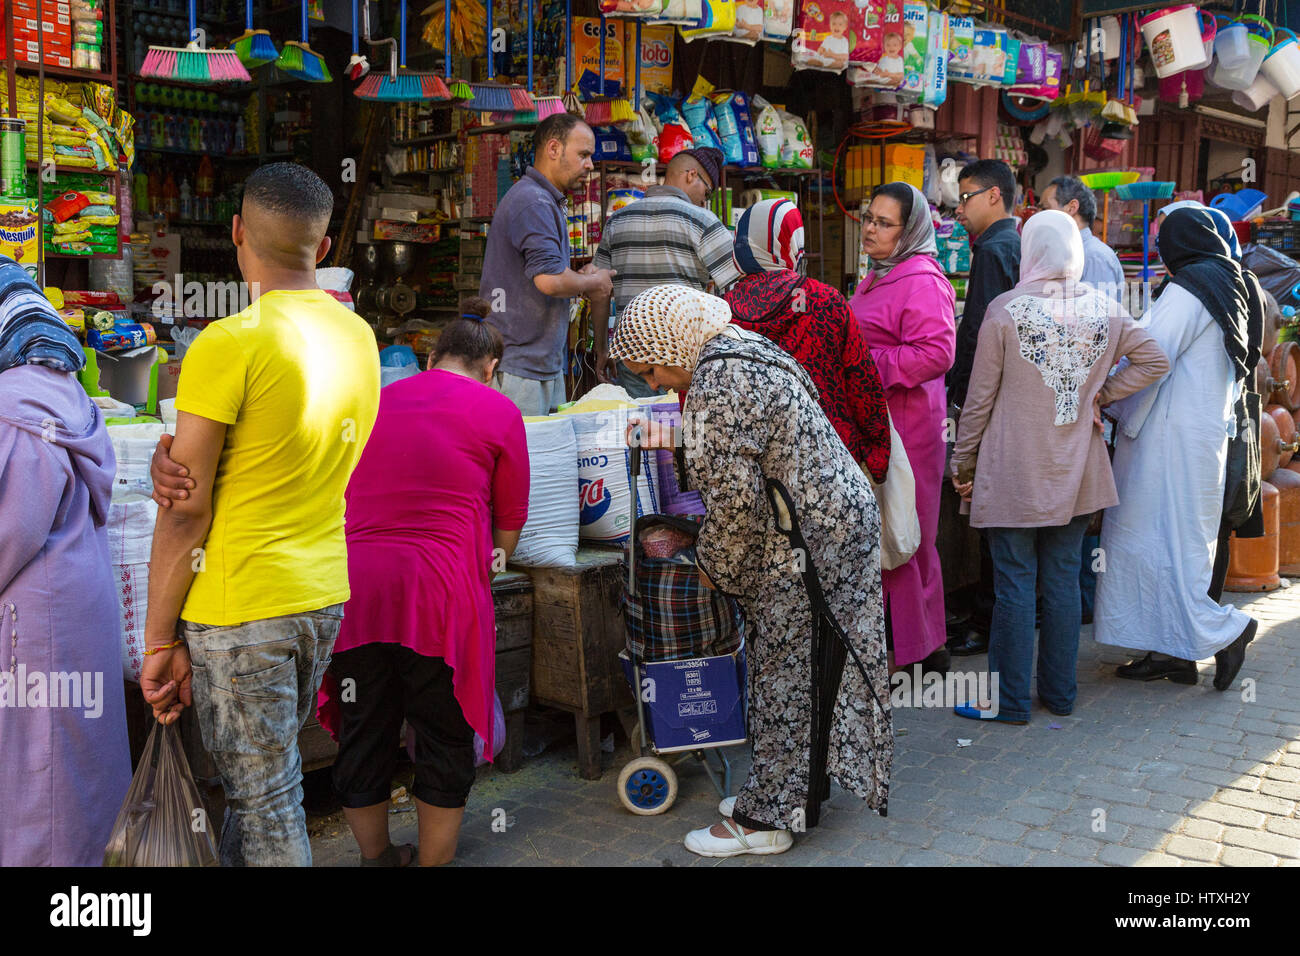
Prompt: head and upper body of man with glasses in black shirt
<box><xmin>948</xmin><ymin>160</ymin><xmax>1021</xmax><ymax>408</ymax></box>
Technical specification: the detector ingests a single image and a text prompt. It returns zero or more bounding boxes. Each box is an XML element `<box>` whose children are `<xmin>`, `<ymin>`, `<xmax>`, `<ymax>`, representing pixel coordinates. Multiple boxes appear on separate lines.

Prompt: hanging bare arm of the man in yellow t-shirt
<box><xmin>140</xmin><ymin>411</ymin><xmax>226</xmax><ymax>722</ymax></box>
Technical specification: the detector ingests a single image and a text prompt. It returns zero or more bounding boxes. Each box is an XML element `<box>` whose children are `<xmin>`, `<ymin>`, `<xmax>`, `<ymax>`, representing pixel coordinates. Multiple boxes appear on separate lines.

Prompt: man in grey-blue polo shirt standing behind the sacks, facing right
<box><xmin>478</xmin><ymin>113</ymin><xmax>614</xmax><ymax>415</ymax></box>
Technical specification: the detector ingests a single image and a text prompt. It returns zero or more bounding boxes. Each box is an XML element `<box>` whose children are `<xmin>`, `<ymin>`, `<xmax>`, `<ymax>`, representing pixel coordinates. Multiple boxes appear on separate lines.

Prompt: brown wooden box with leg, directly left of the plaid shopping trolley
<box><xmin>529</xmin><ymin>548</ymin><xmax>632</xmax><ymax>780</ymax></box>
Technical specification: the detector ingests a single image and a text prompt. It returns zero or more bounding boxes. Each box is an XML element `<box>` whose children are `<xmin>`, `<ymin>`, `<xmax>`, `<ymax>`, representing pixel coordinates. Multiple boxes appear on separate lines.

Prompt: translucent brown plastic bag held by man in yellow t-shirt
<box><xmin>104</xmin><ymin>723</ymin><xmax>217</xmax><ymax>866</ymax></box>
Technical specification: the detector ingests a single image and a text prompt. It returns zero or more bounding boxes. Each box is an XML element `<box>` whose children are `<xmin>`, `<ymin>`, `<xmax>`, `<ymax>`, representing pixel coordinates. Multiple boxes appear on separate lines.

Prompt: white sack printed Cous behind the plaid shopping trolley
<box><xmin>571</xmin><ymin>408</ymin><xmax>659</xmax><ymax>544</ymax></box>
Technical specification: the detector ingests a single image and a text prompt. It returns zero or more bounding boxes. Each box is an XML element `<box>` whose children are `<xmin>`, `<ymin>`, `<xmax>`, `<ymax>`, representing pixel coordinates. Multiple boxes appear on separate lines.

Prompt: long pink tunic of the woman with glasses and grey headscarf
<box><xmin>849</xmin><ymin>255</ymin><xmax>957</xmax><ymax>666</ymax></box>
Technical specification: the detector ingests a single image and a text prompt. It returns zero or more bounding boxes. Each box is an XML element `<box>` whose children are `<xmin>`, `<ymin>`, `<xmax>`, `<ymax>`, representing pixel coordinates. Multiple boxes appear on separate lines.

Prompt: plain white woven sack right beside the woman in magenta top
<box><xmin>511</xmin><ymin>415</ymin><xmax>579</xmax><ymax>567</ymax></box>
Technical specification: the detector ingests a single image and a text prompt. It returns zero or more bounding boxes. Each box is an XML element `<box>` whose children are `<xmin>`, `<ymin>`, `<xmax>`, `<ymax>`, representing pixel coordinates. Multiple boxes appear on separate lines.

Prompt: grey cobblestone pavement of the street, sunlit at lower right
<box><xmin>312</xmin><ymin>583</ymin><xmax>1300</xmax><ymax>866</ymax></box>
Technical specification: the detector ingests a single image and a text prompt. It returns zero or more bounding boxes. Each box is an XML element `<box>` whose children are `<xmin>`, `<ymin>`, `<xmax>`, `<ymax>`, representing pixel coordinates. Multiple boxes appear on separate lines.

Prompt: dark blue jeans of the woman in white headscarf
<box><xmin>988</xmin><ymin>515</ymin><xmax>1092</xmax><ymax>721</ymax></box>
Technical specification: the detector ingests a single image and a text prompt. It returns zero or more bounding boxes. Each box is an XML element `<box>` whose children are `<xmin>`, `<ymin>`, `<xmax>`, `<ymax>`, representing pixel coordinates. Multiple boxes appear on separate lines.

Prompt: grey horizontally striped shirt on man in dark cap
<box><xmin>594</xmin><ymin>186</ymin><xmax>740</xmax><ymax>323</ymax></box>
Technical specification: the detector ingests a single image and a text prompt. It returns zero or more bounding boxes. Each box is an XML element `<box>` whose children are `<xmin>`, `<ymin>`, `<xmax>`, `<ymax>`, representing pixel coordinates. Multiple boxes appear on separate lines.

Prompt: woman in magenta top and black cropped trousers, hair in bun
<box><xmin>322</xmin><ymin>299</ymin><xmax>528</xmax><ymax>866</ymax></box>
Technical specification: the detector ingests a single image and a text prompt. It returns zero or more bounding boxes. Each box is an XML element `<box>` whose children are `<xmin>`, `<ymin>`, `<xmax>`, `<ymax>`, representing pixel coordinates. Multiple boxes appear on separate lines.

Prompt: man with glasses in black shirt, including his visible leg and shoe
<box><xmin>948</xmin><ymin>160</ymin><xmax>1021</xmax><ymax>657</ymax></box>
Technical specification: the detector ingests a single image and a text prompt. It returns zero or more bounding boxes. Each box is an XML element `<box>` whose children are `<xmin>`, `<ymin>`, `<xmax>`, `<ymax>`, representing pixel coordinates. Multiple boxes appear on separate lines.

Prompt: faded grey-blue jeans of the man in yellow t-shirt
<box><xmin>181</xmin><ymin>605</ymin><xmax>343</xmax><ymax>866</ymax></box>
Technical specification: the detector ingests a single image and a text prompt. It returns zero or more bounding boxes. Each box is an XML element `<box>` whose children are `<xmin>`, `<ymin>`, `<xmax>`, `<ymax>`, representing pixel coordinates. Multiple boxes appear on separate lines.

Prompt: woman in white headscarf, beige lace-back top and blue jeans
<box><xmin>950</xmin><ymin>211</ymin><xmax>1169</xmax><ymax>723</ymax></box>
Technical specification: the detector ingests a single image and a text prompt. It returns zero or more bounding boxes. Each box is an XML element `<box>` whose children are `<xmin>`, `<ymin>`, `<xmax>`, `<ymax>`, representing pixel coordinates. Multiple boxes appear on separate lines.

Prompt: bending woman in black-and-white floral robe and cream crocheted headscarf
<box><xmin>610</xmin><ymin>285</ymin><xmax>893</xmax><ymax>856</ymax></box>
